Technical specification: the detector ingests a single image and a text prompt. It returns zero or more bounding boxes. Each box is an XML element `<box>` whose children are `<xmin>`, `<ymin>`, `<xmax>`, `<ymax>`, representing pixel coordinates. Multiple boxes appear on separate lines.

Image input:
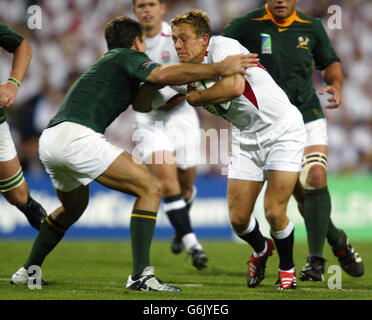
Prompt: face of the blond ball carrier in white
<box><xmin>172</xmin><ymin>23</ymin><xmax>209</xmax><ymax>63</ymax></box>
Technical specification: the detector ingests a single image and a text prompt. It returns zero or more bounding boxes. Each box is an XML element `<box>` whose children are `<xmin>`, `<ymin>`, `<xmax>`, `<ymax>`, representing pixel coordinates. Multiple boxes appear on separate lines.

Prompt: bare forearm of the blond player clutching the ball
<box><xmin>186</xmin><ymin>74</ymin><xmax>245</xmax><ymax>106</ymax></box>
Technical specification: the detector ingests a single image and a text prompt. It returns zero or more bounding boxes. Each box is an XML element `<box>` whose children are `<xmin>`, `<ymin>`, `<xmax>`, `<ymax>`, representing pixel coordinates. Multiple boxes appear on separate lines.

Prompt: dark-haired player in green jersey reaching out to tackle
<box><xmin>11</xmin><ymin>17</ymin><xmax>256</xmax><ymax>291</ymax></box>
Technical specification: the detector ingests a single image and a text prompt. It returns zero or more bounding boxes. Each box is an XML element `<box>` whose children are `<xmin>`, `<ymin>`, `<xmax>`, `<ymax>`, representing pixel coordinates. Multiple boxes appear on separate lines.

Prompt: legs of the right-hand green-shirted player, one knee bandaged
<box><xmin>296</xmin><ymin>145</ymin><xmax>364</xmax><ymax>281</ymax></box>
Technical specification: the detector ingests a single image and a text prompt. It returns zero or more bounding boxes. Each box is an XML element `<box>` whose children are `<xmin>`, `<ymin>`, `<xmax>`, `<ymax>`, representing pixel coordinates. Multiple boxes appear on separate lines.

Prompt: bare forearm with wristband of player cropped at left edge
<box><xmin>0</xmin><ymin>39</ymin><xmax>32</xmax><ymax>107</ymax></box>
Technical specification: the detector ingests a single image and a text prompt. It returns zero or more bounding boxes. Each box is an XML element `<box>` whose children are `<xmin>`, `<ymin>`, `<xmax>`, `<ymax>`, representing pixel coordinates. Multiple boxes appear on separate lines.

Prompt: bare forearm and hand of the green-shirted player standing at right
<box><xmin>320</xmin><ymin>62</ymin><xmax>344</xmax><ymax>109</ymax></box>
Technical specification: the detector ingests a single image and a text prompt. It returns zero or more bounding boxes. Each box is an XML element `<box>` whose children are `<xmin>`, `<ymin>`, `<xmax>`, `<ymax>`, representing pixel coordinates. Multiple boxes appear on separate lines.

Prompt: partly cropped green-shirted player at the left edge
<box><xmin>0</xmin><ymin>23</ymin><xmax>46</xmax><ymax>230</ymax></box>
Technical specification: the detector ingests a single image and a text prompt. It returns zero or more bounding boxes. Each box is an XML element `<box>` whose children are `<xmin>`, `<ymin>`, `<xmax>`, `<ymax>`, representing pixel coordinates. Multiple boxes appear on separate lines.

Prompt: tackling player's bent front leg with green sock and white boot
<box><xmin>96</xmin><ymin>153</ymin><xmax>179</xmax><ymax>291</ymax></box>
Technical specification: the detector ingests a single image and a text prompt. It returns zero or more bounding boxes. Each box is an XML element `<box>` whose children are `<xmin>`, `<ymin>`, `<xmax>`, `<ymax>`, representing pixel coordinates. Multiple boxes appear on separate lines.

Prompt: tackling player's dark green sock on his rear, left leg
<box><xmin>24</xmin><ymin>216</ymin><xmax>66</xmax><ymax>269</ymax></box>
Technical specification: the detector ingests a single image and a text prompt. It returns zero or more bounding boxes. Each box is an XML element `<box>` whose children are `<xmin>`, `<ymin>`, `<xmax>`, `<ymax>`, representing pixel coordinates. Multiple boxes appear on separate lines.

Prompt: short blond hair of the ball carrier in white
<box><xmin>171</xmin><ymin>9</ymin><xmax>212</xmax><ymax>37</ymax></box>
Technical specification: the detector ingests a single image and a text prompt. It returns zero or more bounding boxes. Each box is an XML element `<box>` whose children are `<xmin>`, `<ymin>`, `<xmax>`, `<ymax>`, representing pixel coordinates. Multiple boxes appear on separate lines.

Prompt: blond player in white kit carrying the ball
<box><xmin>171</xmin><ymin>9</ymin><xmax>306</xmax><ymax>289</ymax></box>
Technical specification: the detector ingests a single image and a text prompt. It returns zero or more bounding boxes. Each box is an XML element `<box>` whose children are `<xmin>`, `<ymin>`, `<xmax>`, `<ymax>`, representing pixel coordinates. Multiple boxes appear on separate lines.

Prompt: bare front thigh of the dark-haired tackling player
<box><xmin>95</xmin><ymin>152</ymin><xmax>161</xmax><ymax>196</ymax></box>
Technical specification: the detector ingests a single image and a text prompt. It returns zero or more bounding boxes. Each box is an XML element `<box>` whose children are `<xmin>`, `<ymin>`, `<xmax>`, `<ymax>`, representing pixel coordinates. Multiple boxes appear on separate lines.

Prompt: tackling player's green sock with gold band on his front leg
<box><xmin>130</xmin><ymin>210</ymin><xmax>157</xmax><ymax>279</ymax></box>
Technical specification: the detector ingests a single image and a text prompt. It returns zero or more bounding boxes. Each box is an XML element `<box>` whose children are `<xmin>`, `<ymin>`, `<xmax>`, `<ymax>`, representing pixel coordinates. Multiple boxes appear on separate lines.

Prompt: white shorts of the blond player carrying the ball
<box><xmin>228</xmin><ymin>109</ymin><xmax>306</xmax><ymax>181</ymax></box>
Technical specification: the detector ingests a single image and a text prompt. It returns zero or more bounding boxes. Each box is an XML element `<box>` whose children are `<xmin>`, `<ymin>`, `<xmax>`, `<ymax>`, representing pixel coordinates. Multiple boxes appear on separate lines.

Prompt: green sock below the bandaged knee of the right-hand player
<box><xmin>303</xmin><ymin>187</ymin><xmax>331</xmax><ymax>257</ymax></box>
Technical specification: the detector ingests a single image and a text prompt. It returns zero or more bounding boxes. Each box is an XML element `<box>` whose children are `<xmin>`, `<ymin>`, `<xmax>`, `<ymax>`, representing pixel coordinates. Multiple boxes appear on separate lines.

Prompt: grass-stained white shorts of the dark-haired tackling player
<box><xmin>39</xmin><ymin>122</ymin><xmax>124</xmax><ymax>192</ymax></box>
